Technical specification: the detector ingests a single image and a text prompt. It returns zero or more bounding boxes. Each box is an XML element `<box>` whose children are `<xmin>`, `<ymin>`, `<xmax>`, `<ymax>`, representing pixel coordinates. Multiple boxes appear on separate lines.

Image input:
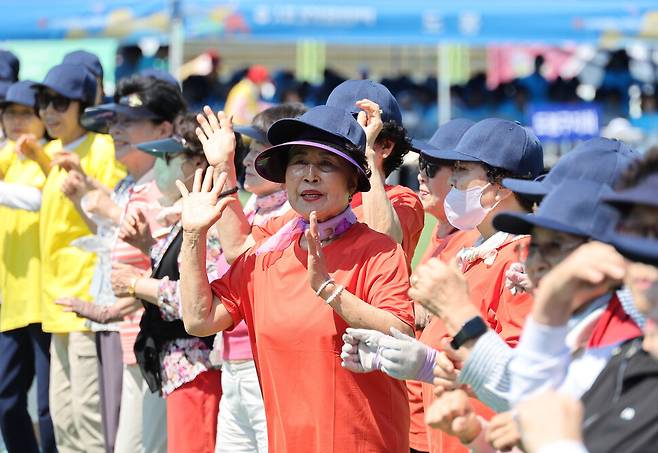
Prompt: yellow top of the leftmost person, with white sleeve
<box><xmin>0</xmin><ymin>142</ymin><xmax>46</xmax><ymax>332</ymax></box>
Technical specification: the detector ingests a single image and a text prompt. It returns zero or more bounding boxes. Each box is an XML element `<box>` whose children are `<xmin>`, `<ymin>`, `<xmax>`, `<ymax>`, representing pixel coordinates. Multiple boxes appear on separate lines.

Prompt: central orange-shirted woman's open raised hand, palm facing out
<box><xmin>176</xmin><ymin>166</ymin><xmax>237</xmax><ymax>237</ymax></box>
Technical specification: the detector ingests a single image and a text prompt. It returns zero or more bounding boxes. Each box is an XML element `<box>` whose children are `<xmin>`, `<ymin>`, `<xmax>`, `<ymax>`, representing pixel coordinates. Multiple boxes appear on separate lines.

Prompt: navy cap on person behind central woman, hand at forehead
<box><xmin>327</xmin><ymin>80</ymin><xmax>402</xmax><ymax>126</ymax></box>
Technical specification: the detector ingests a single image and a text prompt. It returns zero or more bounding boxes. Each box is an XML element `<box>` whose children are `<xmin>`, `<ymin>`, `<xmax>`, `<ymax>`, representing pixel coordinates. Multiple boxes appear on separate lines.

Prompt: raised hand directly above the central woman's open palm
<box><xmin>196</xmin><ymin>105</ymin><xmax>235</xmax><ymax>169</ymax></box>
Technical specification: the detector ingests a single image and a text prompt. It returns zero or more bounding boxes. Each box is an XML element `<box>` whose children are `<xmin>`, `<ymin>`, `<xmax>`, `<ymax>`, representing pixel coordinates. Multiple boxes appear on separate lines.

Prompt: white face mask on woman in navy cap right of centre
<box><xmin>443</xmin><ymin>184</ymin><xmax>496</xmax><ymax>230</ymax></box>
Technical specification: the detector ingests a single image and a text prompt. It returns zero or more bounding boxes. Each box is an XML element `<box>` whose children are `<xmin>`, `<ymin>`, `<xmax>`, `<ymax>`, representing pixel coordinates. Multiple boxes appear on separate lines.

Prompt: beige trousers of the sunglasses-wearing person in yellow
<box><xmin>50</xmin><ymin>332</ymin><xmax>105</xmax><ymax>453</ymax></box>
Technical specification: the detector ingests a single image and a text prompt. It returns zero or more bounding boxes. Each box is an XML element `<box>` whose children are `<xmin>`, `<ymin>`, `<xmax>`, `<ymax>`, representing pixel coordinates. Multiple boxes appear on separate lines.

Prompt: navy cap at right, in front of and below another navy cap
<box><xmin>493</xmin><ymin>180</ymin><xmax>619</xmax><ymax>239</ymax></box>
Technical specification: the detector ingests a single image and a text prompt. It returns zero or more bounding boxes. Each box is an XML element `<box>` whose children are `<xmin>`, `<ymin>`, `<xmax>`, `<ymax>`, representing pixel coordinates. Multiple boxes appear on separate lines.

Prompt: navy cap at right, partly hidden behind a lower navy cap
<box><xmin>503</xmin><ymin>137</ymin><xmax>639</xmax><ymax>200</ymax></box>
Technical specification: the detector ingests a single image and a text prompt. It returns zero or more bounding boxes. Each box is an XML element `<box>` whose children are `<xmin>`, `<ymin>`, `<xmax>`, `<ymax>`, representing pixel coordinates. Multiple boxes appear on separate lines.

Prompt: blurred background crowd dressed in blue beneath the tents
<box><xmin>173</xmin><ymin>49</ymin><xmax>658</xmax><ymax>141</ymax></box>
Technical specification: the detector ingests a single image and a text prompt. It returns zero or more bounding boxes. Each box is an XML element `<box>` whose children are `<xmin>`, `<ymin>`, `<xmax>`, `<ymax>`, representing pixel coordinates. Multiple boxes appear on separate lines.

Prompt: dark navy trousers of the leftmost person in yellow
<box><xmin>0</xmin><ymin>324</ymin><xmax>57</xmax><ymax>453</ymax></box>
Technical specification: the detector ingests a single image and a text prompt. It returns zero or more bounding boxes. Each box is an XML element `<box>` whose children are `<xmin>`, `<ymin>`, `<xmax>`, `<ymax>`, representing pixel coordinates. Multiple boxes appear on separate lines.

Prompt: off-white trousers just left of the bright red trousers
<box><xmin>114</xmin><ymin>365</ymin><xmax>167</xmax><ymax>453</ymax></box>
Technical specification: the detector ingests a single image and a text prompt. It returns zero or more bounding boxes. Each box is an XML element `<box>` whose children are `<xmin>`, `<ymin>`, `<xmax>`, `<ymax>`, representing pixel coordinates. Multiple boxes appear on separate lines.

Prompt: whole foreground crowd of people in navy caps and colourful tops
<box><xmin>0</xmin><ymin>44</ymin><xmax>658</xmax><ymax>453</ymax></box>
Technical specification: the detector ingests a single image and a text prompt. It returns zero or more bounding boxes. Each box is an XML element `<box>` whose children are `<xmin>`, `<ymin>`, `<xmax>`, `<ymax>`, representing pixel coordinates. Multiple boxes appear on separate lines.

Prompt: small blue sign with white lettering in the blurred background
<box><xmin>528</xmin><ymin>102</ymin><xmax>601</xmax><ymax>141</ymax></box>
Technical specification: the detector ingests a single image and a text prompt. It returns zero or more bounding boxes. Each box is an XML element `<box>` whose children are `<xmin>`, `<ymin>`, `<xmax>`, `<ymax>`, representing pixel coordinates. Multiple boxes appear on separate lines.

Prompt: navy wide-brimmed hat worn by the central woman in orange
<box><xmin>254</xmin><ymin>105</ymin><xmax>370</xmax><ymax>192</ymax></box>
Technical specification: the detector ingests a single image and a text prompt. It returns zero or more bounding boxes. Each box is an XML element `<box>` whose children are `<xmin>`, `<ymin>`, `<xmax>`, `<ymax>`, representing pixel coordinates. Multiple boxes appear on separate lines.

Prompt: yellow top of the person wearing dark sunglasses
<box><xmin>39</xmin><ymin>133</ymin><xmax>126</xmax><ymax>333</ymax></box>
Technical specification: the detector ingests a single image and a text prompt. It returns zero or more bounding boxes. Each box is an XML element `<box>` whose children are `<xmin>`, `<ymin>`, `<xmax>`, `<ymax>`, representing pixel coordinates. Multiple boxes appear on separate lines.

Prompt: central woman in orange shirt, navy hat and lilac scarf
<box><xmin>180</xmin><ymin>101</ymin><xmax>414</xmax><ymax>453</ymax></box>
